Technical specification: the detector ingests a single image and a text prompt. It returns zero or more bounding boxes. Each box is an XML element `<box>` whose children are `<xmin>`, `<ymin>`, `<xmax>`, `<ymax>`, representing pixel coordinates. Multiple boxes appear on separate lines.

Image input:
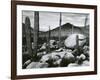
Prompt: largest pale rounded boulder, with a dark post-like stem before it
<box><xmin>64</xmin><ymin>34</ymin><xmax>86</xmax><ymax>48</ymax></box>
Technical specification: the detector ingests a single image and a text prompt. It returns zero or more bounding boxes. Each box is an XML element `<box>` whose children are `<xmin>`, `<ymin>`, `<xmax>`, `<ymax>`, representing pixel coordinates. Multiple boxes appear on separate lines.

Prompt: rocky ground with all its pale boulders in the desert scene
<box><xmin>23</xmin><ymin>34</ymin><xmax>89</xmax><ymax>69</ymax></box>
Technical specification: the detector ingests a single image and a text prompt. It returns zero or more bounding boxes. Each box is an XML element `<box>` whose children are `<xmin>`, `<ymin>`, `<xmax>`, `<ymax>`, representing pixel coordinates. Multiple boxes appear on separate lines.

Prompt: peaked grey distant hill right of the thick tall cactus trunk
<box><xmin>39</xmin><ymin>23</ymin><xmax>89</xmax><ymax>37</ymax></box>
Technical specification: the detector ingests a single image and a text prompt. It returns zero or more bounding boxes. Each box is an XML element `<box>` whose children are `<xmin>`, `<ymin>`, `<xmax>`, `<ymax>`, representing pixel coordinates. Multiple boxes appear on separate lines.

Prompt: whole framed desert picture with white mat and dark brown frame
<box><xmin>11</xmin><ymin>1</ymin><xmax>97</xmax><ymax>79</ymax></box>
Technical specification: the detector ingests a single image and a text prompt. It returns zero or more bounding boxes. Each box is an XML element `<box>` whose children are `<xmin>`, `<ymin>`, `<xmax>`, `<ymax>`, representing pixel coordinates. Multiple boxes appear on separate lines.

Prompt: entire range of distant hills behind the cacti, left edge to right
<box><xmin>22</xmin><ymin>23</ymin><xmax>89</xmax><ymax>41</ymax></box>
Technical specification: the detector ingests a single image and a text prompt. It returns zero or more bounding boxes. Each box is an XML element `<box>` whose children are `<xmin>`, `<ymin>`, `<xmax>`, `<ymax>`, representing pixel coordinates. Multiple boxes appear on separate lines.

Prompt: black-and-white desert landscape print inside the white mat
<box><xmin>22</xmin><ymin>10</ymin><xmax>90</xmax><ymax>69</ymax></box>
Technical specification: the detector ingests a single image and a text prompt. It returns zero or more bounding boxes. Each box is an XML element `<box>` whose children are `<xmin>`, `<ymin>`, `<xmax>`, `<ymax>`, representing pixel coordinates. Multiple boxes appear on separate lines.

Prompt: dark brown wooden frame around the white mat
<box><xmin>11</xmin><ymin>1</ymin><xmax>97</xmax><ymax>80</ymax></box>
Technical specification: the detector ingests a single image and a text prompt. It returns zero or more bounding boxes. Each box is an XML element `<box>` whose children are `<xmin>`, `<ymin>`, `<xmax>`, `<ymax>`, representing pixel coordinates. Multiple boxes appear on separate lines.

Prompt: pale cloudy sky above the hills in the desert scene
<box><xmin>22</xmin><ymin>11</ymin><xmax>89</xmax><ymax>31</ymax></box>
